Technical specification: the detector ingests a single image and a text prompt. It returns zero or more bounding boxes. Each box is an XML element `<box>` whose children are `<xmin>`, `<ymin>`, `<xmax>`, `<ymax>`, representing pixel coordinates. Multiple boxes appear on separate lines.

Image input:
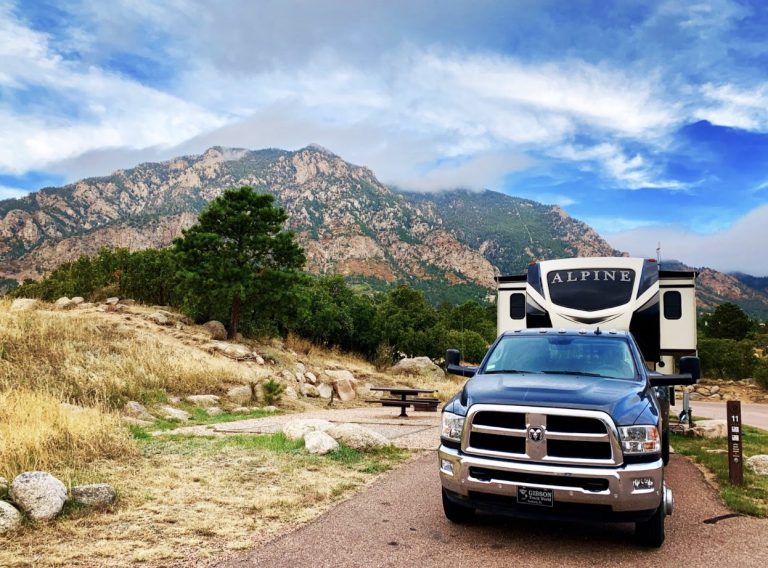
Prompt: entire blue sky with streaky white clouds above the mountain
<box><xmin>0</xmin><ymin>0</ymin><xmax>768</xmax><ymax>275</ymax></box>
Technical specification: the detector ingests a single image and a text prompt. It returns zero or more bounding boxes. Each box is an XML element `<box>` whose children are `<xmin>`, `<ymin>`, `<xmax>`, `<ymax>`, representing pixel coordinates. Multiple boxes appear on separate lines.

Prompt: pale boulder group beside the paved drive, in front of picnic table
<box><xmin>283</xmin><ymin>418</ymin><xmax>389</xmax><ymax>455</ymax></box>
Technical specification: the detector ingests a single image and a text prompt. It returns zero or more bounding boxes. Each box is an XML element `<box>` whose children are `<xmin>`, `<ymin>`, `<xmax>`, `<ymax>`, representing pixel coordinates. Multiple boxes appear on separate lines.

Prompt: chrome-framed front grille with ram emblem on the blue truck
<box><xmin>462</xmin><ymin>405</ymin><xmax>622</xmax><ymax>466</ymax></box>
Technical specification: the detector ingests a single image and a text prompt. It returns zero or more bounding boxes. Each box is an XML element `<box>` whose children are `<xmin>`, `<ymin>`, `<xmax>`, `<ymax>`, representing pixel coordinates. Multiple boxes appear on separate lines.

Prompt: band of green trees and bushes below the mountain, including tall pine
<box><xmin>10</xmin><ymin>187</ymin><xmax>496</xmax><ymax>362</ymax></box>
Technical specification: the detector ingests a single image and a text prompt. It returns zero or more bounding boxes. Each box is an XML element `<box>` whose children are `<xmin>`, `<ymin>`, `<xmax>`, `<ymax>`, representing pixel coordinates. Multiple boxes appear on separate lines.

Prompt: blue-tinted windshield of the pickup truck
<box><xmin>481</xmin><ymin>335</ymin><xmax>637</xmax><ymax>379</ymax></box>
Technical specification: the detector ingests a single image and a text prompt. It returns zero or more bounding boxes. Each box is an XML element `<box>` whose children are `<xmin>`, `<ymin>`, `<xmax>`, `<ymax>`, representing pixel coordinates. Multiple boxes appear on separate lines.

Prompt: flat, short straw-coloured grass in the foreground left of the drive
<box><xmin>0</xmin><ymin>438</ymin><xmax>402</xmax><ymax>566</ymax></box>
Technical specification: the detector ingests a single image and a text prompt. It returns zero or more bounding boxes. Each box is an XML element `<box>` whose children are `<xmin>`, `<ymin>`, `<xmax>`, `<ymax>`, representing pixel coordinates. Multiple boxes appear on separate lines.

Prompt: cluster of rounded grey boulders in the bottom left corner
<box><xmin>0</xmin><ymin>471</ymin><xmax>117</xmax><ymax>534</ymax></box>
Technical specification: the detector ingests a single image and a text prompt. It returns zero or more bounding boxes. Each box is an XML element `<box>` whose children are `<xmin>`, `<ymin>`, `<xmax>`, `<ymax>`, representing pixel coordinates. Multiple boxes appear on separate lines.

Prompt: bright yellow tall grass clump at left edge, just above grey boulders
<box><xmin>0</xmin><ymin>390</ymin><xmax>136</xmax><ymax>479</ymax></box>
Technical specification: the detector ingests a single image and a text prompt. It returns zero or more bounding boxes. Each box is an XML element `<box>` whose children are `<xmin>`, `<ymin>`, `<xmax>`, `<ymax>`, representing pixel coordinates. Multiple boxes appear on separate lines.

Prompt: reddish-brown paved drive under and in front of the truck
<box><xmin>208</xmin><ymin>452</ymin><xmax>768</xmax><ymax>568</ymax></box>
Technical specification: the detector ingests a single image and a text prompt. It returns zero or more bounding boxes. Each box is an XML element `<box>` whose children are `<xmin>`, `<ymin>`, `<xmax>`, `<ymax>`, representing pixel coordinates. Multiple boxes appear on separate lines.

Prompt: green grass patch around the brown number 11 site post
<box><xmin>671</xmin><ymin>426</ymin><xmax>768</xmax><ymax>517</ymax></box>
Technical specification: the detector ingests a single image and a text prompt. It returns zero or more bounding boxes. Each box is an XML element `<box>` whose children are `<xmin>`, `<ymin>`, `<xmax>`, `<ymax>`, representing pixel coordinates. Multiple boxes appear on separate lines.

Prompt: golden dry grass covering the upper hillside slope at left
<box><xmin>0</xmin><ymin>302</ymin><xmax>252</xmax><ymax>407</ymax></box>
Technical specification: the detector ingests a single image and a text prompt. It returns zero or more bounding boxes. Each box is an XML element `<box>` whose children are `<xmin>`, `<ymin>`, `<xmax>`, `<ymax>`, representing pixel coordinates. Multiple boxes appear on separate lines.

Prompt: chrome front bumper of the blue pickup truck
<box><xmin>438</xmin><ymin>445</ymin><xmax>671</xmax><ymax>521</ymax></box>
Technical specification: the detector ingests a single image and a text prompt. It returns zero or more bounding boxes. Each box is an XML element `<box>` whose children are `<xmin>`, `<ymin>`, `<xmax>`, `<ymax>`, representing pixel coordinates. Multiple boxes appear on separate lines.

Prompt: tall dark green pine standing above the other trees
<box><xmin>174</xmin><ymin>187</ymin><xmax>305</xmax><ymax>338</ymax></box>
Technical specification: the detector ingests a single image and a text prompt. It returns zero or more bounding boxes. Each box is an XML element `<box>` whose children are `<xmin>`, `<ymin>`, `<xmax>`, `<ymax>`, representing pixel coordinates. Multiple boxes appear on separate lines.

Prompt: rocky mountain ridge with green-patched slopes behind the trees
<box><xmin>0</xmin><ymin>146</ymin><xmax>768</xmax><ymax>316</ymax></box>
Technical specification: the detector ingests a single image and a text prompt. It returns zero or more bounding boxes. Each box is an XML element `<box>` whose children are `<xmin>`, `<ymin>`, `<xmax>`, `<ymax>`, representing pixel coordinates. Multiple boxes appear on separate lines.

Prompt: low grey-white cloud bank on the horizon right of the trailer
<box><xmin>606</xmin><ymin>205</ymin><xmax>768</xmax><ymax>276</ymax></box>
